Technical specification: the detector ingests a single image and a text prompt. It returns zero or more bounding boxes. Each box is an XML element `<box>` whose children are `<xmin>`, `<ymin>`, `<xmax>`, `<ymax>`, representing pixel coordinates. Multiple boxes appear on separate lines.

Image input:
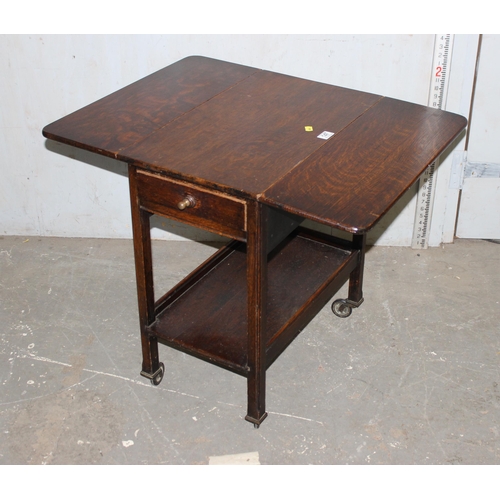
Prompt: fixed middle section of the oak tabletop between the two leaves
<box><xmin>120</xmin><ymin>71</ymin><xmax>381</xmax><ymax>197</ymax></box>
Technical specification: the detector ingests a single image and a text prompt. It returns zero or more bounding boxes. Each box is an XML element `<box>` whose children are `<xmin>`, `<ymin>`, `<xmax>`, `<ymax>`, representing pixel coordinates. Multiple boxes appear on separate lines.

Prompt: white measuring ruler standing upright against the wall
<box><xmin>411</xmin><ymin>35</ymin><xmax>453</xmax><ymax>249</ymax></box>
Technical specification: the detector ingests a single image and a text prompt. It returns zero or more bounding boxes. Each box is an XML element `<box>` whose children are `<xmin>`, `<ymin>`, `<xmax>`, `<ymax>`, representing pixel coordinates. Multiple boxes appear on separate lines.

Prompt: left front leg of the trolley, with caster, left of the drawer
<box><xmin>129</xmin><ymin>166</ymin><xmax>163</xmax><ymax>385</ymax></box>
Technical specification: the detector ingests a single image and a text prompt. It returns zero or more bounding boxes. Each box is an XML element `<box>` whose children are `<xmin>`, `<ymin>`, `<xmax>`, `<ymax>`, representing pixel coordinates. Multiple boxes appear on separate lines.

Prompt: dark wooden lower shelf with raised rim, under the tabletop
<box><xmin>148</xmin><ymin>230</ymin><xmax>359</xmax><ymax>375</ymax></box>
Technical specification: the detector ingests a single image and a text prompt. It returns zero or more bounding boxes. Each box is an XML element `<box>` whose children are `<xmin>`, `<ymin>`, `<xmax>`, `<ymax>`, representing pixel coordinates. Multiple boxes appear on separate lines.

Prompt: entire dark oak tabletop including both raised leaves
<box><xmin>43</xmin><ymin>57</ymin><xmax>467</xmax><ymax>233</ymax></box>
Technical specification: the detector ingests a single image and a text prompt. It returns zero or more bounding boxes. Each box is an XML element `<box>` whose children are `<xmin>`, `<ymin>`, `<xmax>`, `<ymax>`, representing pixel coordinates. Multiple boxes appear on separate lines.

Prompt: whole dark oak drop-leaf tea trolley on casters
<box><xmin>43</xmin><ymin>57</ymin><xmax>466</xmax><ymax>426</ymax></box>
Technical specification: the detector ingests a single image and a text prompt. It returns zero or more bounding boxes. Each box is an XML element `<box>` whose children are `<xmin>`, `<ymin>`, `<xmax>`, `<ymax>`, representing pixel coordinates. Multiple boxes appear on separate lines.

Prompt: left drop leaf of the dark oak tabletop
<box><xmin>43</xmin><ymin>56</ymin><xmax>257</xmax><ymax>157</ymax></box>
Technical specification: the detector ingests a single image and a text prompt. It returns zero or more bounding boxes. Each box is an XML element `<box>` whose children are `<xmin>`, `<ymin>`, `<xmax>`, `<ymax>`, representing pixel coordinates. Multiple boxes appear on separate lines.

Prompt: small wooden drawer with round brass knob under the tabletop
<box><xmin>136</xmin><ymin>170</ymin><xmax>246</xmax><ymax>240</ymax></box>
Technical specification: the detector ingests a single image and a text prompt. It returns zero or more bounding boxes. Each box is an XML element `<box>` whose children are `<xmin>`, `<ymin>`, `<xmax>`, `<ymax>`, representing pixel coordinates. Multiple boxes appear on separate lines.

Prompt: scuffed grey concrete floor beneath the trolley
<box><xmin>0</xmin><ymin>236</ymin><xmax>500</xmax><ymax>464</ymax></box>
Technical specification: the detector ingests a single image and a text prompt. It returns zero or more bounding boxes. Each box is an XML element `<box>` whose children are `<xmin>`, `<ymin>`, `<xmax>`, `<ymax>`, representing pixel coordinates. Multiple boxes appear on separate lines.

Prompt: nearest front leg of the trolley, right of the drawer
<box><xmin>245</xmin><ymin>202</ymin><xmax>268</xmax><ymax>427</ymax></box>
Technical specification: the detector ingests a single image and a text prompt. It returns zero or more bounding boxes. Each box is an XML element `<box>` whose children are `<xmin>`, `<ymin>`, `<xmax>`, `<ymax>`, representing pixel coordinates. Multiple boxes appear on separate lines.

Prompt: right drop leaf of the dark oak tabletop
<box><xmin>262</xmin><ymin>98</ymin><xmax>466</xmax><ymax>233</ymax></box>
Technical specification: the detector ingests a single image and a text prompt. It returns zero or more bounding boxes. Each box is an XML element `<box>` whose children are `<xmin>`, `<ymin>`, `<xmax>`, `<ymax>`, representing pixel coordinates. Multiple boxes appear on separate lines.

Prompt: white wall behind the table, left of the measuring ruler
<box><xmin>0</xmin><ymin>35</ymin><xmax>468</xmax><ymax>245</ymax></box>
